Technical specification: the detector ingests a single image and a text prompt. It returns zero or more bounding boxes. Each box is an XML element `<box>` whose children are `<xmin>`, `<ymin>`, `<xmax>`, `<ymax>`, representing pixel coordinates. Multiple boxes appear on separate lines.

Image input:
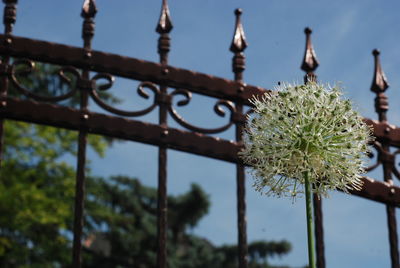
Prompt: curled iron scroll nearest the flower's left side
<box><xmin>168</xmin><ymin>89</ymin><xmax>236</xmax><ymax>134</ymax></box>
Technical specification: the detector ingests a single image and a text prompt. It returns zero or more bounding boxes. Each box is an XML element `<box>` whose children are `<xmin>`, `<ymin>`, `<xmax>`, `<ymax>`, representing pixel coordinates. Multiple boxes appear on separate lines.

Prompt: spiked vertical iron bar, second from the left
<box><xmin>72</xmin><ymin>0</ymin><xmax>97</xmax><ymax>268</ymax></box>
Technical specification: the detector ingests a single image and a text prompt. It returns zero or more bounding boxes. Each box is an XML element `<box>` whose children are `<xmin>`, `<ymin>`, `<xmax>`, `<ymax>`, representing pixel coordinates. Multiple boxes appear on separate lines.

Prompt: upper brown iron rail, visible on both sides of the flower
<box><xmin>0</xmin><ymin>35</ymin><xmax>400</xmax><ymax>143</ymax></box>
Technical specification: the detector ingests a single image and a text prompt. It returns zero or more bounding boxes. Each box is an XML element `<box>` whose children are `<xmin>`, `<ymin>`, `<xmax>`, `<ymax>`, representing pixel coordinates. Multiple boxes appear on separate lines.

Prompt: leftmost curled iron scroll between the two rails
<box><xmin>10</xmin><ymin>59</ymin><xmax>80</xmax><ymax>102</ymax></box>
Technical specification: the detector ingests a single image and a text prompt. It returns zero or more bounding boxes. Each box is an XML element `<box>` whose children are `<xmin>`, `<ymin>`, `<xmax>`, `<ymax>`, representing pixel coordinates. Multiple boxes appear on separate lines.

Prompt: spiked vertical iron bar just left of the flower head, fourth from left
<box><xmin>230</xmin><ymin>8</ymin><xmax>248</xmax><ymax>268</ymax></box>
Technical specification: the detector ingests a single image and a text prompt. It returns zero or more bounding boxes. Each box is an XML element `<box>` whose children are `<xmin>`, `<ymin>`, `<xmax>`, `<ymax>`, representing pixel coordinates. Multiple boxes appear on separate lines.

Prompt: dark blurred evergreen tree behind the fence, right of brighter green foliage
<box><xmin>86</xmin><ymin>176</ymin><xmax>291</xmax><ymax>268</ymax></box>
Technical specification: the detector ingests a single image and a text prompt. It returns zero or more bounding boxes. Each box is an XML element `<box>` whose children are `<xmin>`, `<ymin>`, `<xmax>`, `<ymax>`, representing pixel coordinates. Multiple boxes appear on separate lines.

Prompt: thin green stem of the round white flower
<box><xmin>303</xmin><ymin>172</ymin><xmax>316</xmax><ymax>268</ymax></box>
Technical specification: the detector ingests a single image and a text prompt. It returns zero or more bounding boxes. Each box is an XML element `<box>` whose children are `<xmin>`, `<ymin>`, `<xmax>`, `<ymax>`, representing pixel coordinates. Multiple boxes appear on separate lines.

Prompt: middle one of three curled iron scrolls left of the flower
<box><xmin>90</xmin><ymin>76</ymin><xmax>160</xmax><ymax>117</ymax></box>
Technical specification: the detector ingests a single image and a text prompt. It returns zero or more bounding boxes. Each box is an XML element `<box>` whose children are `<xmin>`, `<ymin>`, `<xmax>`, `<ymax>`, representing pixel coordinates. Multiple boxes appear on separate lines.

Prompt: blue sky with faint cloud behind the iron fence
<box><xmin>10</xmin><ymin>0</ymin><xmax>400</xmax><ymax>268</ymax></box>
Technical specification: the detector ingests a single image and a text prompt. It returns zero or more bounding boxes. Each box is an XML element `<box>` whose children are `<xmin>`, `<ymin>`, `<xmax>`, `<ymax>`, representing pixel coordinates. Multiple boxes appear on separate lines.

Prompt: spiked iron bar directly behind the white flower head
<box><xmin>301</xmin><ymin>27</ymin><xmax>326</xmax><ymax>268</ymax></box>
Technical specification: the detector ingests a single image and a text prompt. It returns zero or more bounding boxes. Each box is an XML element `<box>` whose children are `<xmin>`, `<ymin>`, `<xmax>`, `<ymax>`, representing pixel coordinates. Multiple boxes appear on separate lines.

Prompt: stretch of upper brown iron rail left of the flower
<box><xmin>0</xmin><ymin>35</ymin><xmax>268</xmax><ymax>104</ymax></box>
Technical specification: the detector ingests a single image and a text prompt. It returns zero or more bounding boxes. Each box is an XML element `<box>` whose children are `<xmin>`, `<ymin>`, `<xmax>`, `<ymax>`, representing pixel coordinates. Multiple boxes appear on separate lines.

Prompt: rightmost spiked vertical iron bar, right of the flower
<box><xmin>371</xmin><ymin>49</ymin><xmax>400</xmax><ymax>268</ymax></box>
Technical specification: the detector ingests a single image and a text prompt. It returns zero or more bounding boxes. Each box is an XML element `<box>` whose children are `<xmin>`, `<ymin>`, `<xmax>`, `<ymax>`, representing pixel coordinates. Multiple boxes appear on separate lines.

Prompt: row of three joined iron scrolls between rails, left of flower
<box><xmin>8</xmin><ymin>59</ymin><xmax>236</xmax><ymax>134</ymax></box>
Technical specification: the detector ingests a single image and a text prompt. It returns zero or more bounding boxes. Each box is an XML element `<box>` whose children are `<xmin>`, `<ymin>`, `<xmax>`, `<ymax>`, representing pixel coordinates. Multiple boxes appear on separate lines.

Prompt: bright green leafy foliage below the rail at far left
<box><xmin>0</xmin><ymin>121</ymin><xmax>108</xmax><ymax>267</ymax></box>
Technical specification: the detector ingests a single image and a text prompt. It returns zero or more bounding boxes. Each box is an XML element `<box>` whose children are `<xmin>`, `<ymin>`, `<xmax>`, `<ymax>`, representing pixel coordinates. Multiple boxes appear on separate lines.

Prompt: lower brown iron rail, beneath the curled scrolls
<box><xmin>0</xmin><ymin>97</ymin><xmax>400</xmax><ymax>207</ymax></box>
